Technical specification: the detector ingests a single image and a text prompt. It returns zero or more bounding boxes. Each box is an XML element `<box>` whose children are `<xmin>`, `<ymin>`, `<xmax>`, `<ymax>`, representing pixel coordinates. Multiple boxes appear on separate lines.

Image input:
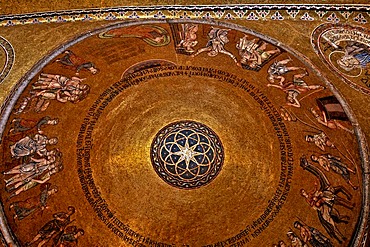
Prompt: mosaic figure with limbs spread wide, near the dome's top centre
<box><xmin>192</xmin><ymin>27</ymin><xmax>238</xmax><ymax>63</ymax></box>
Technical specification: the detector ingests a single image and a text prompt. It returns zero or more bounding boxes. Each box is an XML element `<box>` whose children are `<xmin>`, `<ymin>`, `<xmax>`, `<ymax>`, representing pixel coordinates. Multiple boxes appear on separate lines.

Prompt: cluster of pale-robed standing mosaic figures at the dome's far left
<box><xmin>3</xmin><ymin>116</ymin><xmax>63</xmax><ymax>198</ymax></box>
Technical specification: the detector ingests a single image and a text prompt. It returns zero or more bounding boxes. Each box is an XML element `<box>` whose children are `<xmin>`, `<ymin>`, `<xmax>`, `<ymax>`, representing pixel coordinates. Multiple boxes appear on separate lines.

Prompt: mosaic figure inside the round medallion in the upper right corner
<box><xmin>337</xmin><ymin>42</ymin><xmax>370</xmax><ymax>71</ymax></box>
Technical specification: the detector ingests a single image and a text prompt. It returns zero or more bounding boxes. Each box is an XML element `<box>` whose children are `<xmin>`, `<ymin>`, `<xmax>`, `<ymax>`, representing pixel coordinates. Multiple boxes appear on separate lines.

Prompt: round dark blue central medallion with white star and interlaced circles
<box><xmin>150</xmin><ymin>121</ymin><xmax>224</xmax><ymax>189</ymax></box>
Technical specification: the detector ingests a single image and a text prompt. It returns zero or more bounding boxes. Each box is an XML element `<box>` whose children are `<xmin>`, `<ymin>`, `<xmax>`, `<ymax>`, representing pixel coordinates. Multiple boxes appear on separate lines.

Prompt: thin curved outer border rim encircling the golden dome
<box><xmin>0</xmin><ymin>17</ymin><xmax>370</xmax><ymax>246</ymax></box>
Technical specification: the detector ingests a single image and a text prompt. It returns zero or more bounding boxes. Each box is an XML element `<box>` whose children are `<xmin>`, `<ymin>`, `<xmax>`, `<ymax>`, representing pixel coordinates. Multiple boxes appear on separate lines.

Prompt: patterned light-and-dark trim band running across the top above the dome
<box><xmin>0</xmin><ymin>4</ymin><xmax>370</xmax><ymax>26</ymax></box>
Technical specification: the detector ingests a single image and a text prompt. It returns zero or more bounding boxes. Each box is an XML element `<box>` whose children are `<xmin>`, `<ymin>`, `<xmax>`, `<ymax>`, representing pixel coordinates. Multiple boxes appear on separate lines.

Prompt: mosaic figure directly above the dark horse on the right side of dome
<box><xmin>311</xmin><ymin>154</ymin><xmax>358</xmax><ymax>190</ymax></box>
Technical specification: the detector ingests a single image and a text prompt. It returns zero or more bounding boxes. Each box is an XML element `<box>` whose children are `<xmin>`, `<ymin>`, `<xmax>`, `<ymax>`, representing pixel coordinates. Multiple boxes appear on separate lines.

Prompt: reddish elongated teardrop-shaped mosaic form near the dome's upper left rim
<box><xmin>99</xmin><ymin>25</ymin><xmax>171</xmax><ymax>46</ymax></box>
